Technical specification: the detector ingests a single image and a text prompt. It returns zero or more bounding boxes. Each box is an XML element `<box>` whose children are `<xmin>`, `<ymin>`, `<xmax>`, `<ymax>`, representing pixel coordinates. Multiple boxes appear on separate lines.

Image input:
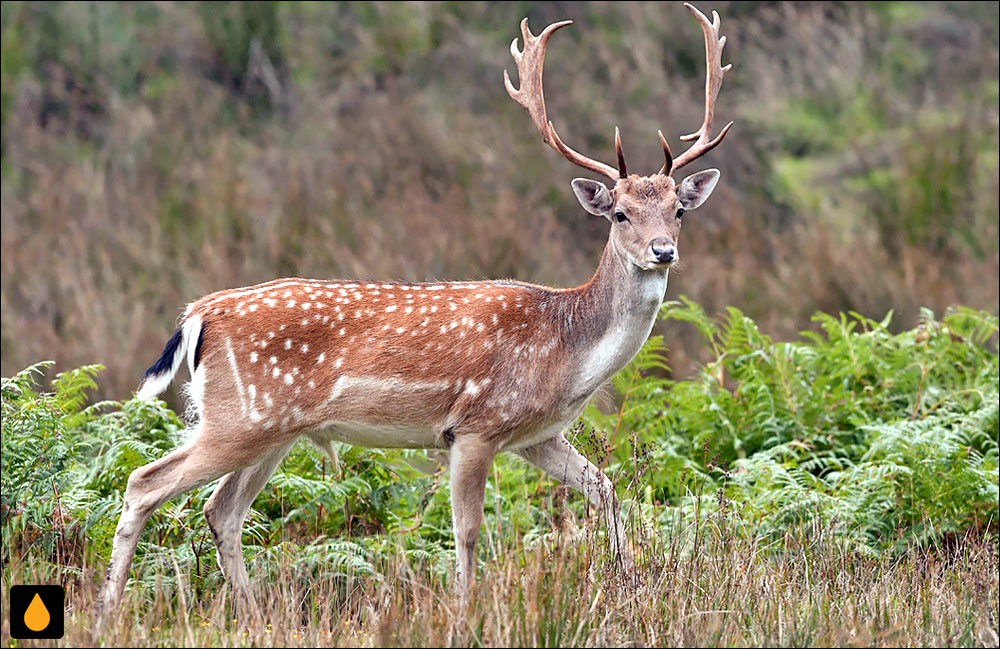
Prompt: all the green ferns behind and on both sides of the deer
<box><xmin>0</xmin><ymin>298</ymin><xmax>998</xmax><ymax>598</ymax></box>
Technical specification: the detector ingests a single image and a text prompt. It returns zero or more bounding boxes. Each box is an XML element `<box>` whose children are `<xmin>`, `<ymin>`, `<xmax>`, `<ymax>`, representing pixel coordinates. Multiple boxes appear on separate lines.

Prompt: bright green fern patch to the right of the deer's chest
<box><xmin>586</xmin><ymin>298</ymin><xmax>998</xmax><ymax>553</ymax></box>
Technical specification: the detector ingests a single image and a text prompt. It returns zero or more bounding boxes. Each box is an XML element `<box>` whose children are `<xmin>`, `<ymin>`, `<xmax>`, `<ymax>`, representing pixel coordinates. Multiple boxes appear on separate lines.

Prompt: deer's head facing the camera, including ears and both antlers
<box><xmin>504</xmin><ymin>4</ymin><xmax>733</xmax><ymax>270</ymax></box>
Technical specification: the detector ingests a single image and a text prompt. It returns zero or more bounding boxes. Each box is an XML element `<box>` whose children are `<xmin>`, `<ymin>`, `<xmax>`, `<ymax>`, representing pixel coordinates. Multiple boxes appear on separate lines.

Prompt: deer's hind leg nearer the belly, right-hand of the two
<box><xmin>204</xmin><ymin>441</ymin><xmax>294</xmax><ymax>623</ymax></box>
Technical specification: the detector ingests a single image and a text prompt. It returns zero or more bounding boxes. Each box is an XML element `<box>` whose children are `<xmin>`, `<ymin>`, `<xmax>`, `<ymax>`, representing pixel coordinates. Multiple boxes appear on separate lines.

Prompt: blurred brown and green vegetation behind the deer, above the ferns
<box><xmin>0</xmin><ymin>2</ymin><xmax>1000</xmax><ymax>398</ymax></box>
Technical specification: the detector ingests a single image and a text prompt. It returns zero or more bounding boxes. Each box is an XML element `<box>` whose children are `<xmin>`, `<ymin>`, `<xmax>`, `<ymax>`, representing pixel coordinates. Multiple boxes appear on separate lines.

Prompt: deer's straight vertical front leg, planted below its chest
<box><xmin>450</xmin><ymin>435</ymin><xmax>496</xmax><ymax>597</ymax></box>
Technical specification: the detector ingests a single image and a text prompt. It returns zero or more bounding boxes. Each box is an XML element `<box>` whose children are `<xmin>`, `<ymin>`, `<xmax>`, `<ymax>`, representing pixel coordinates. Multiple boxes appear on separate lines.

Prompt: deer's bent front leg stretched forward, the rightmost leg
<box><xmin>516</xmin><ymin>434</ymin><xmax>634</xmax><ymax>571</ymax></box>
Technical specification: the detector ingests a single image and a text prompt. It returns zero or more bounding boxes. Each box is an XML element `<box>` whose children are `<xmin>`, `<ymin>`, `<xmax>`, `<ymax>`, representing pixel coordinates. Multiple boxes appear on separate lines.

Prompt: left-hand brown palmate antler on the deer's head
<box><xmin>503</xmin><ymin>18</ymin><xmax>625</xmax><ymax>180</ymax></box>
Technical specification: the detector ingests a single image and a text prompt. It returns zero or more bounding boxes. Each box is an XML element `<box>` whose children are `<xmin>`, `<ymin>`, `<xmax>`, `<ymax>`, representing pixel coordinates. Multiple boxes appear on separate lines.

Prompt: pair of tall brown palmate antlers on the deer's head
<box><xmin>503</xmin><ymin>3</ymin><xmax>733</xmax><ymax>180</ymax></box>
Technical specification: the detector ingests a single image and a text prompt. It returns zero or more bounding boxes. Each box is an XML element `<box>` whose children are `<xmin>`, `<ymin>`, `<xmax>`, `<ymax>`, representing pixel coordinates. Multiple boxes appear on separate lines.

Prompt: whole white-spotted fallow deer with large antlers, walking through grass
<box><xmin>97</xmin><ymin>4</ymin><xmax>733</xmax><ymax>629</ymax></box>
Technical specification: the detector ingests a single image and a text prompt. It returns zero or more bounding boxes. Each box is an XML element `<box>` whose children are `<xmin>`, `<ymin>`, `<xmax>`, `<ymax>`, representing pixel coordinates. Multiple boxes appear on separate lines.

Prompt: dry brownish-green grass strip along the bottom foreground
<box><xmin>2</xmin><ymin>509</ymin><xmax>1000</xmax><ymax>647</ymax></box>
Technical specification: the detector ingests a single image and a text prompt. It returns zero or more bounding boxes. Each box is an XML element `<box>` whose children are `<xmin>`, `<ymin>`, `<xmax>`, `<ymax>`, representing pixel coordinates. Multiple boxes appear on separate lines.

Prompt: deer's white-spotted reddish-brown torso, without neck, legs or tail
<box><xmin>186</xmin><ymin>278</ymin><xmax>575</xmax><ymax>448</ymax></box>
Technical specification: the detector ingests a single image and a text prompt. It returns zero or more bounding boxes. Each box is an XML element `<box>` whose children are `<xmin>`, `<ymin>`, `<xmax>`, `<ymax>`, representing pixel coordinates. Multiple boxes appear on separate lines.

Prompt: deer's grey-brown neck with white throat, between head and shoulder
<box><xmin>562</xmin><ymin>241</ymin><xmax>667</xmax><ymax>398</ymax></box>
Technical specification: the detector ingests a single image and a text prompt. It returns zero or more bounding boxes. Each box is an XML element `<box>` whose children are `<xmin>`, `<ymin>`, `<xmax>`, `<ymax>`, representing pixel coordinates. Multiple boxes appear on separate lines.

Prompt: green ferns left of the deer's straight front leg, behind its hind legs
<box><xmin>0</xmin><ymin>363</ymin><xmax>458</xmax><ymax>598</ymax></box>
